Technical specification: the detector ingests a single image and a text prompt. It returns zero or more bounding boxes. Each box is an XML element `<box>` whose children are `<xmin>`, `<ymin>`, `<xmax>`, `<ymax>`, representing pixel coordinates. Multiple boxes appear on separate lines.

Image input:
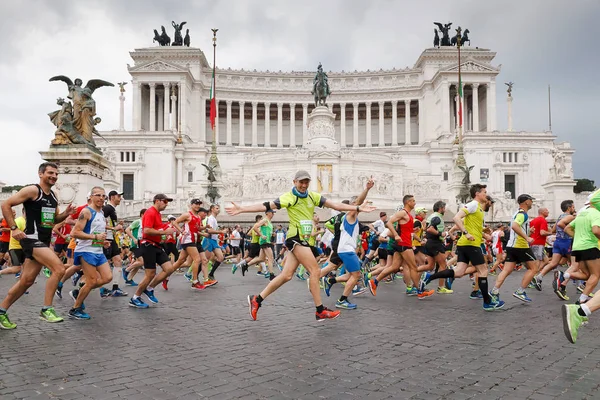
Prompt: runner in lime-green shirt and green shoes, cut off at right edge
<box><xmin>562</xmin><ymin>190</ymin><xmax>600</xmax><ymax>343</ymax></box>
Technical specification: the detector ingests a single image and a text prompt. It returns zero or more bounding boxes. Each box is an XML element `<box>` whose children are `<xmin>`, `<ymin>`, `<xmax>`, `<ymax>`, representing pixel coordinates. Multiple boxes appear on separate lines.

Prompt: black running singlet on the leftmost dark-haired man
<box><xmin>23</xmin><ymin>185</ymin><xmax>58</xmax><ymax>243</ymax></box>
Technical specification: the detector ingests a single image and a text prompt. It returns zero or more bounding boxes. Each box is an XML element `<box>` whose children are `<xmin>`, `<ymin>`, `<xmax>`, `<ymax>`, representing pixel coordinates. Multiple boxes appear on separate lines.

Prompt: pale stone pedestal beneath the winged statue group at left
<box><xmin>40</xmin><ymin>144</ymin><xmax>110</xmax><ymax>206</ymax></box>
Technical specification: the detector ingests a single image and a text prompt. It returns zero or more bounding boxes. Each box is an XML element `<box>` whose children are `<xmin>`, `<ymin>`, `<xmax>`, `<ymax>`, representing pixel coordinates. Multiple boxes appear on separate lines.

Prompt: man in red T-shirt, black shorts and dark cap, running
<box><xmin>129</xmin><ymin>193</ymin><xmax>179</xmax><ymax>308</ymax></box>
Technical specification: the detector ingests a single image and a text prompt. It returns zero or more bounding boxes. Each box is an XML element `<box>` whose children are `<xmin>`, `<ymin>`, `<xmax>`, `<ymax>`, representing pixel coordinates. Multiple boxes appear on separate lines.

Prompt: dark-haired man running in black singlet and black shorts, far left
<box><xmin>0</xmin><ymin>162</ymin><xmax>74</xmax><ymax>329</ymax></box>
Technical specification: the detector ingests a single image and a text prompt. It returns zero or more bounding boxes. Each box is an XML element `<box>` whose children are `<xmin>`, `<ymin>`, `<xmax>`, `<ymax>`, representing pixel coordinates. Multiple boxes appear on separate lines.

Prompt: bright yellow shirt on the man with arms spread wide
<box><xmin>274</xmin><ymin>191</ymin><xmax>327</xmax><ymax>241</ymax></box>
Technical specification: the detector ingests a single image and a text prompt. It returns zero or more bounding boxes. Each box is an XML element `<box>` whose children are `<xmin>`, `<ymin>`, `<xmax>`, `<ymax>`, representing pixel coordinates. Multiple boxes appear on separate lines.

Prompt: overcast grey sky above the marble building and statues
<box><xmin>0</xmin><ymin>0</ymin><xmax>600</xmax><ymax>184</ymax></box>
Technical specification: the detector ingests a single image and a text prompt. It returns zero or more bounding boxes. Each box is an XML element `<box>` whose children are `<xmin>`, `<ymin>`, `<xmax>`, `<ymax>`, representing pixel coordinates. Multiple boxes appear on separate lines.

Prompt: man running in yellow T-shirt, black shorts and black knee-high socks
<box><xmin>421</xmin><ymin>183</ymin><xmax>504</xmax><ymax>311</ymax></box>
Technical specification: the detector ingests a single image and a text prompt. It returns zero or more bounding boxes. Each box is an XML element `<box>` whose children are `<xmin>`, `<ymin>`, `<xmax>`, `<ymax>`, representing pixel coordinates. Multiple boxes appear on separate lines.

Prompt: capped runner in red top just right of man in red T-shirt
<box><xmin>170</xmin><ymin>199</ymin><xmax>208</xmax><ymax>290</ymax></box>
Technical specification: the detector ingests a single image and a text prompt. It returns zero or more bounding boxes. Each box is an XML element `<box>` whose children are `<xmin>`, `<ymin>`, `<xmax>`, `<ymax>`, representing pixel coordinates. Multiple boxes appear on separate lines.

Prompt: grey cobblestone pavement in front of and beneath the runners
<box><xmin>0</xmin><ymin>265</ymin><xmax>600</xmax><ymax>400</ymax></box>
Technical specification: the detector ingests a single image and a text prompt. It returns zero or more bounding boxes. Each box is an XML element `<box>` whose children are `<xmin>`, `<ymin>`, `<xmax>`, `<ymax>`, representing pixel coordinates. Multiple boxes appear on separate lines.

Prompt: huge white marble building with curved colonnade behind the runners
<box><xmin>98</xmin><ymin>47</ymin><xmax>575</xmax><ymax>219</ymax></box>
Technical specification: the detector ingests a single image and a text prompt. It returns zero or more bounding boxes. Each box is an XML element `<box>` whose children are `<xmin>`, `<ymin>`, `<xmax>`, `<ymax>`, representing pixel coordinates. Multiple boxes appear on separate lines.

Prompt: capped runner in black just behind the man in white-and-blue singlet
<box><xmin>100</xmin><ymin>190</ymin><xmax>127</xmax><ymax>298</ymax></box>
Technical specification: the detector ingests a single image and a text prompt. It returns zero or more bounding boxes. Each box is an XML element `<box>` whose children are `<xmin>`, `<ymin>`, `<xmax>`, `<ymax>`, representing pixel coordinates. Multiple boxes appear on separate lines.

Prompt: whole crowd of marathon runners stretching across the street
<box><xmin>0</xmin><ymin>163</ymin><xmax>600</xmax><ymax>343</ymax></box>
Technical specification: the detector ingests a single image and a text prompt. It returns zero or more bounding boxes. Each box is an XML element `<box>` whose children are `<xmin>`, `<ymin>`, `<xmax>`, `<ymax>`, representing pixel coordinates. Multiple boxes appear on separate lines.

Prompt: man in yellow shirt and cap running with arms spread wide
<box><xmin>226</xmin><ymin>170</ymin><xmax>376</xmax><ymax>321</ymax></box>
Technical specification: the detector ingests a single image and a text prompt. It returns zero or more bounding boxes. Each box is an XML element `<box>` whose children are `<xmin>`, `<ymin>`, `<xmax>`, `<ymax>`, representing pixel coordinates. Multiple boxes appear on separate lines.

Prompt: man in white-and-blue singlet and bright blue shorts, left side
<box><xmin>69</xmin><ymin>186</ymin><xmax>112</xmax><ymax>319</ymax></box>
